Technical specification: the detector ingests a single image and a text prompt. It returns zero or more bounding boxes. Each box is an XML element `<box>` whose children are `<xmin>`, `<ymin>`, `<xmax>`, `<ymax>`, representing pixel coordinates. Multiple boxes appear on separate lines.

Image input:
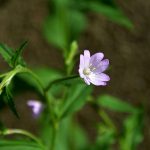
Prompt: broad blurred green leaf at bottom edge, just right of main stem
<box><xmin>56</xmin><ymin>117</ymin><xmax>89</xmax><ymax>150</ymax></box>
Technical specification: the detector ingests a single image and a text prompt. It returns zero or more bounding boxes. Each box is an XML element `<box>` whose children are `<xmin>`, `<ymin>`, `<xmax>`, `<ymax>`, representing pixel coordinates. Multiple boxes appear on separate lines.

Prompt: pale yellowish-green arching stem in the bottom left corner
<box><xmin>0</xmin><ymin>129</ymin><xmax>45</xmax><ymax>149</ymax></box>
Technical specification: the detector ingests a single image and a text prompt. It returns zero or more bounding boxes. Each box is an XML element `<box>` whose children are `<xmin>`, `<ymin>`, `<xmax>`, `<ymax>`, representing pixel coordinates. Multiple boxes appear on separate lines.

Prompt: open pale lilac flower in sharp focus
<box><xmin>79</xmin><ymin>50</ymin><xmax>110</xmax><ymax>86</ymax></box>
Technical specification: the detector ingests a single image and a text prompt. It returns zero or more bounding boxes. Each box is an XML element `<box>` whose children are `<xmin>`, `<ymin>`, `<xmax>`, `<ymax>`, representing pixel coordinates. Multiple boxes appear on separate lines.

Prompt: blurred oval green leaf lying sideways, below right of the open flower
<box><xmin>97</xmin><ymin>95</ymin><xmax>137</xmax><ymax>113</ymax></box>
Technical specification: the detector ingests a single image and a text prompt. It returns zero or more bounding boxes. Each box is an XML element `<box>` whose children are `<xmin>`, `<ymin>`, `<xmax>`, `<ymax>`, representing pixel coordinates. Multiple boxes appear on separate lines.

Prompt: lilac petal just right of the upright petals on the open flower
<box><xmin>90</xmin><ymin>53</ymin><xmax>104</xmax><ymax>68</ymax></box>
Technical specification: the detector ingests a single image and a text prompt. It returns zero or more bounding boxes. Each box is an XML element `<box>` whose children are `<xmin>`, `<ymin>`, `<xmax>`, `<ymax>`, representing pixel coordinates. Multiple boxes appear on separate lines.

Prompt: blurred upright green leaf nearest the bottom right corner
<box><xmin>120</xmin><ymin>109</ymin><xmax>143</xmax><ymax>150</ymax></box>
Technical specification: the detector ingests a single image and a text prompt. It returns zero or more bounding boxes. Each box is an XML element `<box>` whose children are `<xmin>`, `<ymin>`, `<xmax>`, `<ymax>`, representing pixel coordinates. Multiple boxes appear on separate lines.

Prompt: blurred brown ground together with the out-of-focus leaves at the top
<box><xmin>0</xmin><ymin>0</ymin><xmax>150</xmax><ymax>150</ymax></box>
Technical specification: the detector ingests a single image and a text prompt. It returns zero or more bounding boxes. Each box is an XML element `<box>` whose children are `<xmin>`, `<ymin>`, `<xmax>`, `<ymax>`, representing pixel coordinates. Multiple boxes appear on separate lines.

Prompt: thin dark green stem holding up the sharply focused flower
<box><xmin>45</xmin><ymin>75</ymin><xmax>79</xmax><ymax>92</ymax></box>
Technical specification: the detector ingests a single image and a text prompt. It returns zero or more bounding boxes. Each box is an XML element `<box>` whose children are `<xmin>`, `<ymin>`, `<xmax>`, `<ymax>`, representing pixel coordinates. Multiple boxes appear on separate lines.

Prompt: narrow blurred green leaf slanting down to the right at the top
<box><xmin>88</xmin><ymin>1</ymin><xmax>133</xmax><ymax>29</ymax></box>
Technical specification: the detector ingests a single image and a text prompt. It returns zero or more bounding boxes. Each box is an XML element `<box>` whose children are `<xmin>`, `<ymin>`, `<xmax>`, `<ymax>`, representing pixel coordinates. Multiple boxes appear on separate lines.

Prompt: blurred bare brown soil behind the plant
<box><xmin>0</xmin><ymin>0</ymin><xmax>150</xmax><ymax>150</ymax></box>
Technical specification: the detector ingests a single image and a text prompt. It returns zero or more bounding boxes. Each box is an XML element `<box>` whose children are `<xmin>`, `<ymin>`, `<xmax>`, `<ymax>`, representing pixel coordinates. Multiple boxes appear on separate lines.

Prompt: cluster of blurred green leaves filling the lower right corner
<box><xmin>96</xmin><ymin>95</ymin><xmax>144</xmax><ymax>150</ymax></box>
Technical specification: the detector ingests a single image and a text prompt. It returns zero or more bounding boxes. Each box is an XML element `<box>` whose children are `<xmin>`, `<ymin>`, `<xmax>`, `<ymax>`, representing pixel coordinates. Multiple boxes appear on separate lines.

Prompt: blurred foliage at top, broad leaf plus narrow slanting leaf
<box><xmin>44</xmin><ymin>0</ymin><xmax>133</xmax><ymax>49</ymax></box>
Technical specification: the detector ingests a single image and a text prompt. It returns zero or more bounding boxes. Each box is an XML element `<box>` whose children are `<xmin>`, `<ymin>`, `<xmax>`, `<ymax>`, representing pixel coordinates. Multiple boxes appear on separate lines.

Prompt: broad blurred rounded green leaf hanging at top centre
<box><xmin>44</xmin><ymin>0</ymin><xmax>87</xmax><ymax>49</ymax></box>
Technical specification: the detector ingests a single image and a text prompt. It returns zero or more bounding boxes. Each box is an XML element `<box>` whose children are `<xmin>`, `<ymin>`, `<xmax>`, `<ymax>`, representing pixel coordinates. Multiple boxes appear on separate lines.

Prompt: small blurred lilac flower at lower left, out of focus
<box><xmin>27</xmin><ymin>100</ymin><xmax>43</xmax><ymax>117</ymax></box>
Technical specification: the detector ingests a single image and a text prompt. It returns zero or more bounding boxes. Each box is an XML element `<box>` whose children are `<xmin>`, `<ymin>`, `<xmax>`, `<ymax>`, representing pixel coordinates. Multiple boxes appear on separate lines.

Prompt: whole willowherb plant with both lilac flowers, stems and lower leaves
<box><xmin>0</xmin><ymin>42</ymin><xmax>143</xmax><ymax>150</ymax></box>
